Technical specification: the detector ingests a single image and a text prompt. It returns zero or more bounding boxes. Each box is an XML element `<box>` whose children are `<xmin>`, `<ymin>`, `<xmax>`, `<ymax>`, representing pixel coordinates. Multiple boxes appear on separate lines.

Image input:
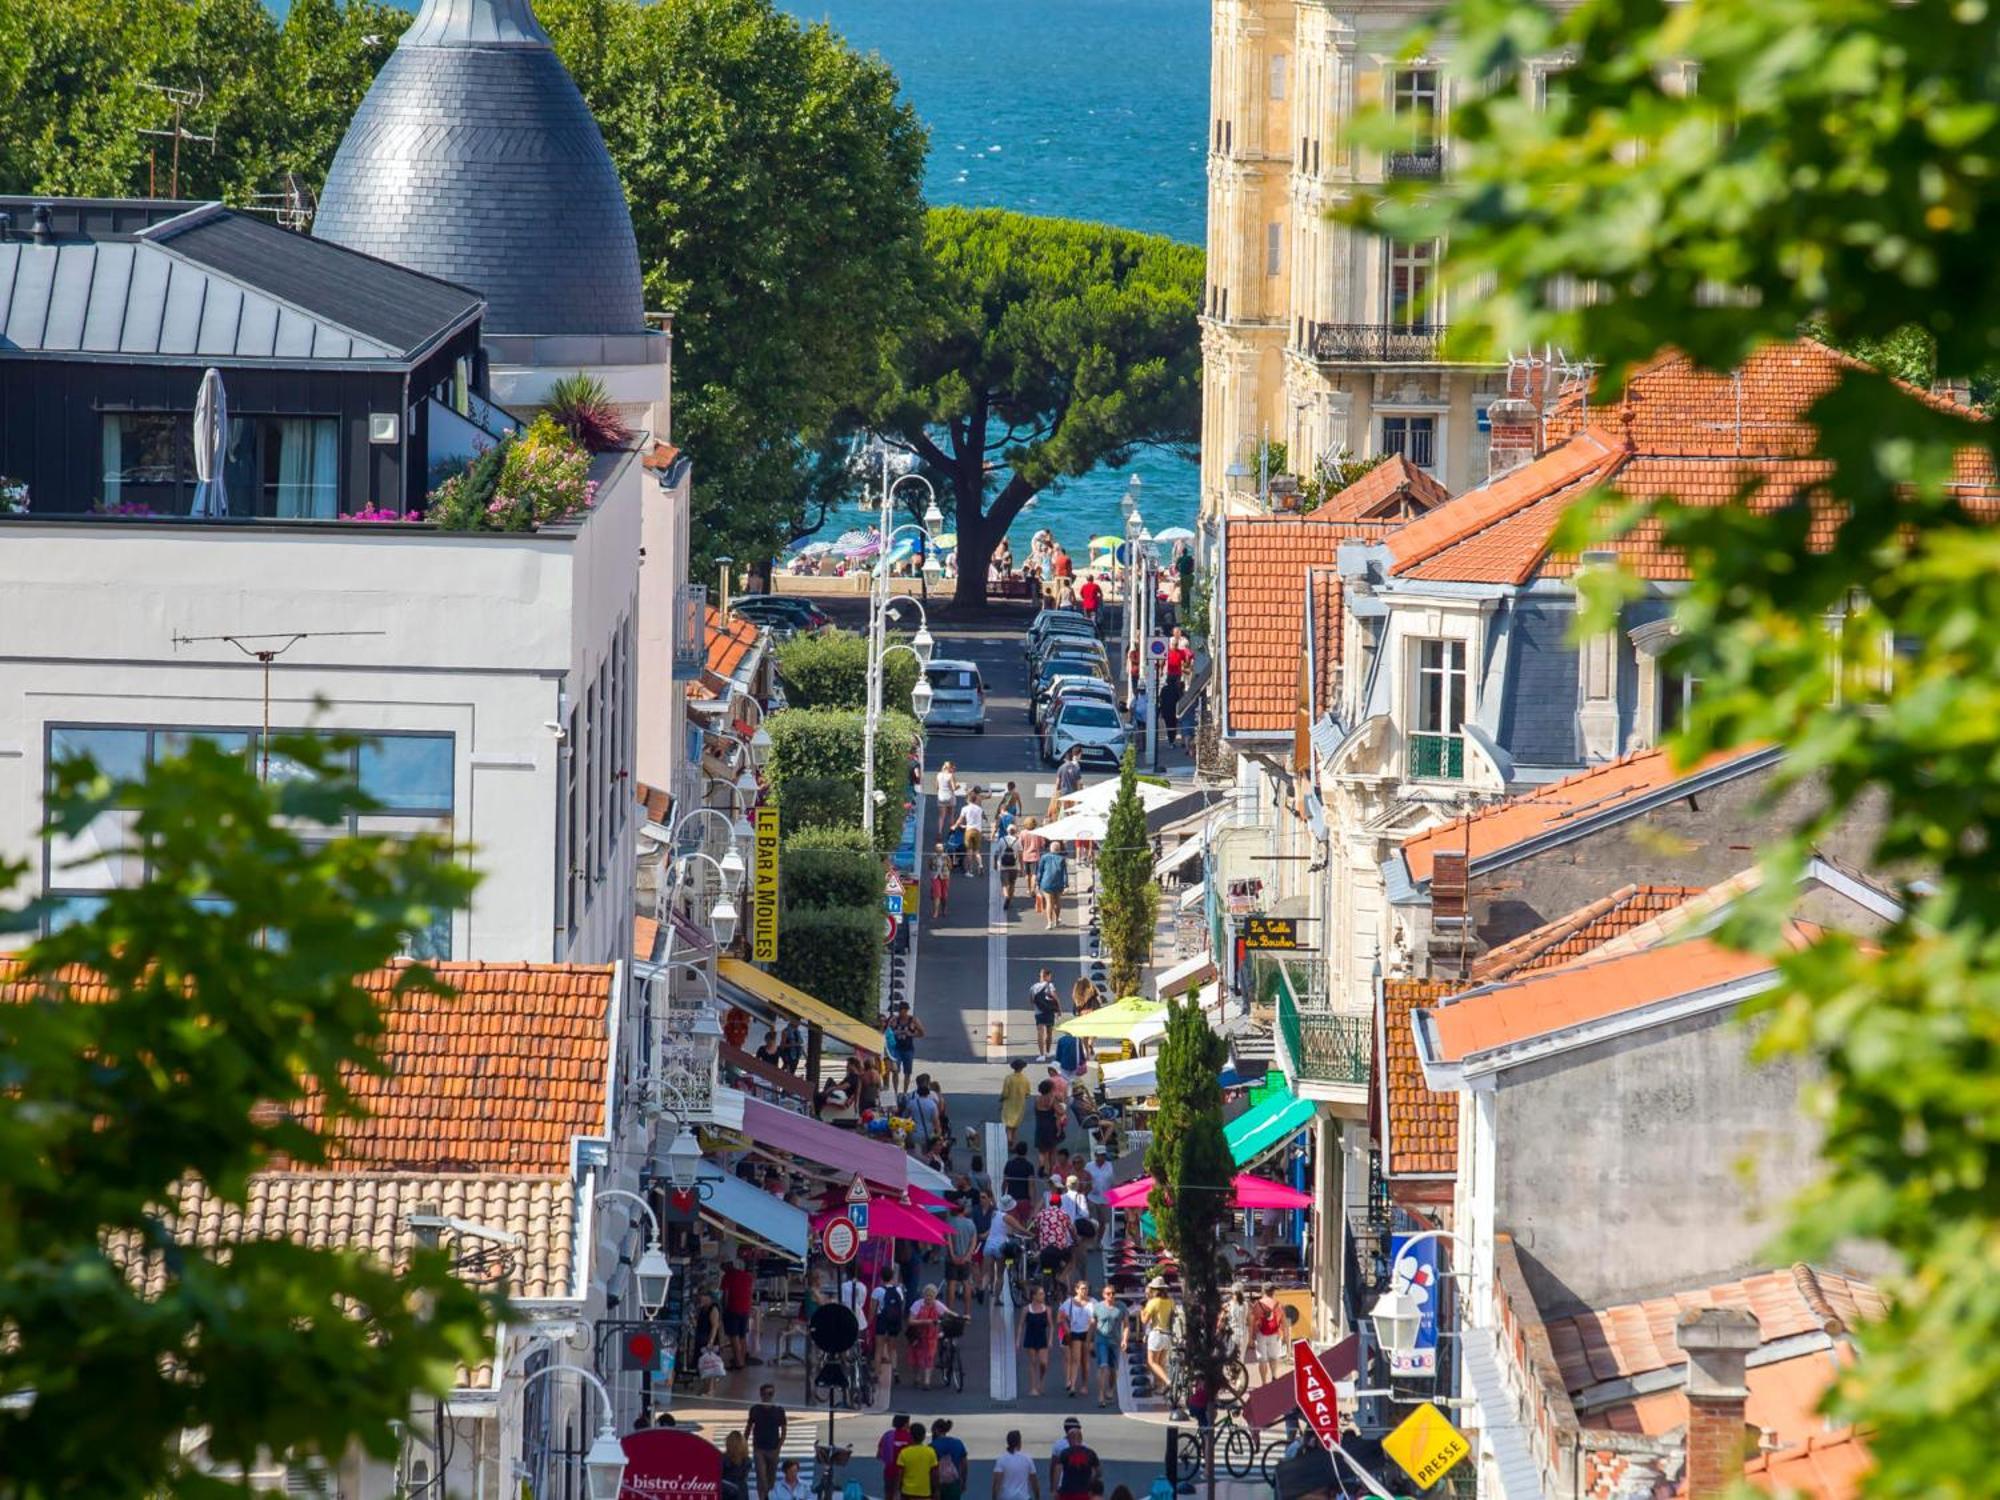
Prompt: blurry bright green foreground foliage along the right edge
<box><xmin>1354</xmin><ymin>0</ymin><xmax>2000</xmax><ymax>1500</ymax></box>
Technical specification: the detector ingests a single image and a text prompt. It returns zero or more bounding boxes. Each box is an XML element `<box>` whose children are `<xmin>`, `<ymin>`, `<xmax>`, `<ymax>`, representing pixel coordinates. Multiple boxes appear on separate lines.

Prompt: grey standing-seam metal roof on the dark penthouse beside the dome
<box><xmin>0</xmin><ymin>200</ymin><xmax>482</xmax><ymax>364</ymax></box>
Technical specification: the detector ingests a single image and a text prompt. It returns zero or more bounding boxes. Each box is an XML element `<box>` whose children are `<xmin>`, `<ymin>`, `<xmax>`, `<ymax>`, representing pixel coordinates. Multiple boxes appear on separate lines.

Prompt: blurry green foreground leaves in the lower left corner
<box><xmin>0</xmin><ymin>736</ymin><xmax>502</xmax><ymax>1500</ymax></box>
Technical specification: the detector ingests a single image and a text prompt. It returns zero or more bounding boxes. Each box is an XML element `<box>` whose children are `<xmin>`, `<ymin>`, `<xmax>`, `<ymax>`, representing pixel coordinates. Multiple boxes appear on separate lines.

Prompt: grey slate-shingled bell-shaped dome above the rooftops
<box><xmin>312</xmin><ymin>0</ymin><xmax>646</xmax><ymax>334</ymax></box>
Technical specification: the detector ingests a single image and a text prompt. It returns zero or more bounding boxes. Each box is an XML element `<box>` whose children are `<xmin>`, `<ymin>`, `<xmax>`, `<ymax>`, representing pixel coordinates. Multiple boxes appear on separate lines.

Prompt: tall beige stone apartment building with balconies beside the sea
<box><xmin>1202</xmin><ymin>0</ymin><xmax>1538</xmax><ymax>522</ymax></box>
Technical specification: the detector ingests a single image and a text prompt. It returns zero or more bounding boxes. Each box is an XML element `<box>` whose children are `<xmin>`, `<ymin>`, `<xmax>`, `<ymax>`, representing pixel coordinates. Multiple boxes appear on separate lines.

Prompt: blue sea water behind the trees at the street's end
<box><xmin>780</xmin><ymin>0</ymin><xmax>1208</xmax><ymax>556</ymax></box>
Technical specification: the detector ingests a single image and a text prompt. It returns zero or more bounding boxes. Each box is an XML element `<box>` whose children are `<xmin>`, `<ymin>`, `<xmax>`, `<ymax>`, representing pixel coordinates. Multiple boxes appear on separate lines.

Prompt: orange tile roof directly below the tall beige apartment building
<box><xmin>1222</xmin><ymin>514</ymin><xmax>1396</xmax><ymax>734</ymax></box>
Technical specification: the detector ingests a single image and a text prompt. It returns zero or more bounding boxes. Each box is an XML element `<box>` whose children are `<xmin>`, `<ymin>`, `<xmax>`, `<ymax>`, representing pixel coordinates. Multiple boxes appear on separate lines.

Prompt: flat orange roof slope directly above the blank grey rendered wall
<box><xmin>1426</xmin><ymin>938</ymin><xmax>1772</xmax><ymax>1062</ymax></box>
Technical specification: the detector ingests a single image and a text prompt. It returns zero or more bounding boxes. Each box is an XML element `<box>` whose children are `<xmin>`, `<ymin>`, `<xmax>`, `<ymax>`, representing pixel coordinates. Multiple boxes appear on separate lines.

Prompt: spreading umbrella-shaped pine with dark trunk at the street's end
<box><xmin>870</xmin><ymin>208</ymin><xmax>1202</xmax><ymax>604</ymax></box>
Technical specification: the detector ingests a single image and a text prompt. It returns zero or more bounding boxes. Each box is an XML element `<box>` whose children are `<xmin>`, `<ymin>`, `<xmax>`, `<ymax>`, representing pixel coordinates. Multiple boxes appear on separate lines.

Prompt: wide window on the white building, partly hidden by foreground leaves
<box><xmin>42</xmin><ymin>724</ymin><xmax>456</xmax><ymax>958</ymax></box>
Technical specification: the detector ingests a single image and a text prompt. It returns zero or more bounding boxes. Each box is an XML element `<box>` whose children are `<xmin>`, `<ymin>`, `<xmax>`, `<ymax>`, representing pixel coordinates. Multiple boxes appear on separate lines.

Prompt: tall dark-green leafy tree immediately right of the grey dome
<box><xmin>538</xmin><ymin>0</ymin><xmax>926</xmax><ymax>574</ymax></box>
